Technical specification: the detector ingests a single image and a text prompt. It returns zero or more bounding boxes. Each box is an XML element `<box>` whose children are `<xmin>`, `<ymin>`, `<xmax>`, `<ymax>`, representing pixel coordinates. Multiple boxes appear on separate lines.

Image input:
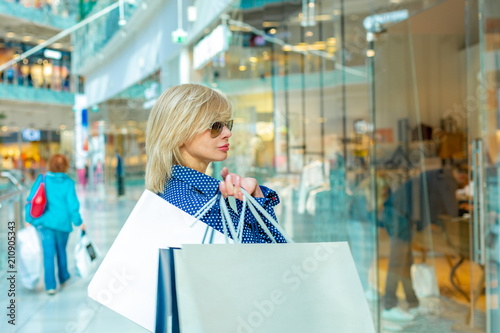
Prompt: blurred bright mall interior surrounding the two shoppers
<box><xmin>0</xmin><ymin>0</ymin><xmax>500</xmax><ymax>333</ymax></box>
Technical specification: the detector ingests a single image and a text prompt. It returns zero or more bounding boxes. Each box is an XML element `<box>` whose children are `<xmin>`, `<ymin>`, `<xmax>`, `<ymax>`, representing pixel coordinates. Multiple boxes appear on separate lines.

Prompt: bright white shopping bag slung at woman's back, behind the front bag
<box><xmin>88</xmin><ymin>190</ymin><xmax>224</xmax><ymax>331</ymax></box>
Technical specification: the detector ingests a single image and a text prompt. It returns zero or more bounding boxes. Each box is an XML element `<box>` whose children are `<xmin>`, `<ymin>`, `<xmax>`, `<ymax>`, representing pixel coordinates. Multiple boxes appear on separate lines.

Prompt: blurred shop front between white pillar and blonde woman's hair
<box><xmin>80</xmin><ymin>71</ymin><xmax>161</xmax><ymax>191</ymax></box>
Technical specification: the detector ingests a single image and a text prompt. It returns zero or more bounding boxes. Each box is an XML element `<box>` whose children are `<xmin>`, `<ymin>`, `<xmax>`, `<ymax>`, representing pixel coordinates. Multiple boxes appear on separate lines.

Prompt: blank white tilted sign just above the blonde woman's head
<box><xmin>193</xmin><ymin>25</ymin><xmax>231</xmax><ymax>69</ymax></box>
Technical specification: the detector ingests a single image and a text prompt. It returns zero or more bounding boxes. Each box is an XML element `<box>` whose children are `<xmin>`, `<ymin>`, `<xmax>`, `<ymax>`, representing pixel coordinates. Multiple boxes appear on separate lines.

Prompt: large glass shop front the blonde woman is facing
<box><xmin>185</xmin><ymin>0</ymin><xmax>500</xmax><ymax>332</ymax></box>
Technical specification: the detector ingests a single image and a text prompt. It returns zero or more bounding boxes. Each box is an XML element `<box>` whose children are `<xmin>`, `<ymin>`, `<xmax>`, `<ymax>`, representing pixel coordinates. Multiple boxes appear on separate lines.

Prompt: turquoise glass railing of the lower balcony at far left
<box><xmin>0</xmin><ymin>84</ymin><xmax>75</xmax><ymax>105</ymax></box>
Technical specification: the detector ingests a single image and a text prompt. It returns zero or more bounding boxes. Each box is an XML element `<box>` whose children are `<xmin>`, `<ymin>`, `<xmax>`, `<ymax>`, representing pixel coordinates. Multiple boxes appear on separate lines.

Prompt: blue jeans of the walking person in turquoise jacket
<box><xmin>39</xmin><ymin>227</ymin><xmax>69</xmax><ymax>290</ymax></box>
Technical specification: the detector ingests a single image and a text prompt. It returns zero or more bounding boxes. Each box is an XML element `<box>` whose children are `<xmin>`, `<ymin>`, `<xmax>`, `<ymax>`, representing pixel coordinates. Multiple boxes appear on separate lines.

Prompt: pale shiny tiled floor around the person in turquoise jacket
<box><xmin>0</xmin><ymin>187</ymin><xmax>147</xmax><ymax>333</ymax></box>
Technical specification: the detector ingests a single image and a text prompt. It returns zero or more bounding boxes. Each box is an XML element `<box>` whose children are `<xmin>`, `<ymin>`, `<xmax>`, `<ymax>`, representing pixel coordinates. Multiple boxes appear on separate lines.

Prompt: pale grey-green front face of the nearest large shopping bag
<box><xmin>174</xmin><ymin>242</ymin><xmax>375</xmax><ymax>333</ymax></box>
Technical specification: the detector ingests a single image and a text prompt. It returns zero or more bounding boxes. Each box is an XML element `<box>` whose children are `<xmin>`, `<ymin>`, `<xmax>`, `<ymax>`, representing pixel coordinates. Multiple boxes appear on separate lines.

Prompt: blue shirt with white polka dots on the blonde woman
<box><xmin>158</xmin><ymin>165</ymin><xmax>286</xmax><ymax>243</ymax></box>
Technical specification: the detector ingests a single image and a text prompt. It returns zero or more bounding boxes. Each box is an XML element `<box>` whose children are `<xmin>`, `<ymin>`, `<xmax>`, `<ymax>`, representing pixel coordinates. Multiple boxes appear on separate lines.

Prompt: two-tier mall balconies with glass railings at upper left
<box><xmin>0</xmin><ymin>0</ymin><xmax>81</xmax><ymax>130</ymax></box>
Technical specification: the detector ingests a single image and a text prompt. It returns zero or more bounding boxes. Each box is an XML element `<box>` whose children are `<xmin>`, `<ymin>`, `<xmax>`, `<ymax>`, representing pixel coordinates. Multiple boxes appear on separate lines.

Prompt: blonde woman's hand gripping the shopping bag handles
<box><xmin>219</xmin><ymin>167</ymin><xmax>264</xmax><ymax>200</ymax></box>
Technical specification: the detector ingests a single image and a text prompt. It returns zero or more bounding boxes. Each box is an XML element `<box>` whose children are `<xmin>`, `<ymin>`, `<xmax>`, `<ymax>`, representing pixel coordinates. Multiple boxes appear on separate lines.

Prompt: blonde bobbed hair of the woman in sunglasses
<box><xmin>146</xmin><ymin>83</ymin><xmax>232</xmax><ymax>193</ymax></box>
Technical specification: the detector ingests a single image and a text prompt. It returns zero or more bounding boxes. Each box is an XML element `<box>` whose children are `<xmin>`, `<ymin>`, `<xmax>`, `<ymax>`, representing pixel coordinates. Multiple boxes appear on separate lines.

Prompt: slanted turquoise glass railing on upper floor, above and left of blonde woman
<box><xmin>72</xmin><ymin>0</ymin><xmax>142</xmax><ymax>71</ymax></box>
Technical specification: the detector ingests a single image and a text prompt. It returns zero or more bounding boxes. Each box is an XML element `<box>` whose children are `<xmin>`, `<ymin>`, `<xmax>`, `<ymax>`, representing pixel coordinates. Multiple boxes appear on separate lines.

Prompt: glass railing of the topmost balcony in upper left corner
<box><xmin>0</xmin><ymin>0</ymin><xmax>77</xmax><ymax>30</ymax></box>
